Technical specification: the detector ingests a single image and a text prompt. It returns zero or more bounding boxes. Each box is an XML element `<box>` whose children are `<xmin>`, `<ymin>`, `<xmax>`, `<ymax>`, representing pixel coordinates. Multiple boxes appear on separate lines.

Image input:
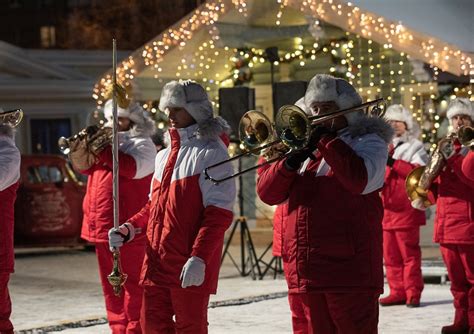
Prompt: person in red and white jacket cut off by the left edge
<box><xmin>0</xmin><ymin>108</ymin><xmax>21</xmax><ymax>334</ymax></box>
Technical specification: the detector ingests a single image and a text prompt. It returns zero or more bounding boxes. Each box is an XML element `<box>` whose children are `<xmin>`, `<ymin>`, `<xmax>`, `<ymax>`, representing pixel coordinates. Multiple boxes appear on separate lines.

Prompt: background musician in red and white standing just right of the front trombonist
<box><xmin>379</xmin><ymin>104</ymin><xmax>428</xmax><ymax>307</ymax></box>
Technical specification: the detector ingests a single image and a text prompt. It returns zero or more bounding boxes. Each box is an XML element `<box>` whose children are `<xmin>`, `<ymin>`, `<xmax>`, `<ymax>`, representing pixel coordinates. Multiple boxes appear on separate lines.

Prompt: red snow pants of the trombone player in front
<box><xmin>288</xmin><ymin>292</ymin><xmax>379</xmax><ymax>334</ymax></box>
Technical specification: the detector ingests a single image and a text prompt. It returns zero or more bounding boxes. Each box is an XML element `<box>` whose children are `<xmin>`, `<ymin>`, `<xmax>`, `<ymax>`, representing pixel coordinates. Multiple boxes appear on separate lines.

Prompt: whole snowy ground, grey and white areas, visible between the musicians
<box><xmin>10</xmin><ymin>251</ymin><xmax>453</xmax><ymax>334</ymax></box>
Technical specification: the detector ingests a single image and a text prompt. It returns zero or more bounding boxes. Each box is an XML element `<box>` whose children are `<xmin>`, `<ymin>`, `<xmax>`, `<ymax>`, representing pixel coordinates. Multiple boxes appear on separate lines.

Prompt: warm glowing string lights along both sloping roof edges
<box><xmin>93</xmin><ymin>0</ymin><xmax>474</xmax><ymax>105</ymax></box>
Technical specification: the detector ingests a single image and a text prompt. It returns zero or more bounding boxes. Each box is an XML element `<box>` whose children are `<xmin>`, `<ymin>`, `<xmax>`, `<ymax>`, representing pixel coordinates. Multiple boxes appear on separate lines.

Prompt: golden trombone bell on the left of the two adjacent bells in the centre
<box><xmin>239</xmin><ymin>110</ymin><xmax>275</xmax><ymax>155</ymax></box>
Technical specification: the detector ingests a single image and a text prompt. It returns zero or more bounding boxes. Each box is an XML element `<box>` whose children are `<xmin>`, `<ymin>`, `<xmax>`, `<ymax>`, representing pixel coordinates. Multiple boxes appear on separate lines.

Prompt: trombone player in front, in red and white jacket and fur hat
<box><xmin>257</xmin><ymin>74</ymin><xmax>393</xmax><ymax>334</ymax></box>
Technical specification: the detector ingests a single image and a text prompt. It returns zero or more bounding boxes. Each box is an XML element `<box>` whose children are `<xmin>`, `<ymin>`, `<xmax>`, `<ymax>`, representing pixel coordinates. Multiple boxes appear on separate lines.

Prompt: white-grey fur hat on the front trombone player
<box><xmin>304</xmin><ymin>74</ymin><xmax>362</xmax><ymax>109</ymax></box>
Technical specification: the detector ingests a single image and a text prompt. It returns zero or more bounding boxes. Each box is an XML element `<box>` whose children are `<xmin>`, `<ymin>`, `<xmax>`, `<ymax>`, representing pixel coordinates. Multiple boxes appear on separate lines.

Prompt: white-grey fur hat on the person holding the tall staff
<box><xmin>159</xmin><ymin>80</ymin><xmax>213</xmax><ymax>124</ymax></box>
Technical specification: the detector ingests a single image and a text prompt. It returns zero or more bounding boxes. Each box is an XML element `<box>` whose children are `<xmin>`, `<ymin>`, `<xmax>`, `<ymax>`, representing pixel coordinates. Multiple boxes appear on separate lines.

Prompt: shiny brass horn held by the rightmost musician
<box><xmin>405</xmin><ymin>127</ymin><xmax>474</xmax><ymax>208</ymax></box>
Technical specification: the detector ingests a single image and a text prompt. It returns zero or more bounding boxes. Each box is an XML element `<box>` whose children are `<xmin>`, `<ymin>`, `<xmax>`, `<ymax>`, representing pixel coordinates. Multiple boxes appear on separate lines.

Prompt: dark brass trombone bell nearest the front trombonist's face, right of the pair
<box><xmin>275</xmin><ymin>105</ymin><xmax>311</xmax><ymax>150</ymax></box>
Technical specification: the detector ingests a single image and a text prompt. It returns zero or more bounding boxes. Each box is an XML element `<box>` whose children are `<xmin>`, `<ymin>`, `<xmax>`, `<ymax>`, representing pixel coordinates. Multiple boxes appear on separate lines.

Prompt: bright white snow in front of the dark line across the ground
<box><xmin>47</xmin><ymin>285</ymin><xmax>453</xmax><ymax>334</ymax></box>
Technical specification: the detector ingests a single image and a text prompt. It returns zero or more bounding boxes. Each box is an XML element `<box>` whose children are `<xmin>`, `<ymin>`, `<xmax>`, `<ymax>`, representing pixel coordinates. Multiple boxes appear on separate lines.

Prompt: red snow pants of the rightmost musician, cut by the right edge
<box><xmin>440</xmin><ymin>244</ymin><xmax>474</xmax><ymax>327</ymax></box>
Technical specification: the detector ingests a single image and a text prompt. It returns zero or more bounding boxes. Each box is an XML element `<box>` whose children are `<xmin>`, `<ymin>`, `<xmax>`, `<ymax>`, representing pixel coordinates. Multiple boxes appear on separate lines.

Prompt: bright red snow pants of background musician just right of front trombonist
<box><xmin>383</xmin><ymin>226</ymin><xmax>424</xmax><ymax>300</ymax></box>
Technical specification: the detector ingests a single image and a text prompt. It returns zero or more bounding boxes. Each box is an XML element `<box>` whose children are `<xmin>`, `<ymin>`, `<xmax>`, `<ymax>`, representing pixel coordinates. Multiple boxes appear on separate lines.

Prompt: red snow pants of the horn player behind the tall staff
<box><xmin>95</xmin><ymin>238</ymin><xmax>145</xmax><ymax>334</ymax></box>
